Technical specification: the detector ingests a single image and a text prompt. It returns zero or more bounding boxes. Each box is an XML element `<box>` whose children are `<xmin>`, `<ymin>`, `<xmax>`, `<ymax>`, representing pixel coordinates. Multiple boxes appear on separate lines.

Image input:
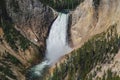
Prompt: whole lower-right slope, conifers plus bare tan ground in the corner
<box><xmin>46</xmin><ymin>21</ymin><xmax>120</xmax><ymax>80</ymax></box>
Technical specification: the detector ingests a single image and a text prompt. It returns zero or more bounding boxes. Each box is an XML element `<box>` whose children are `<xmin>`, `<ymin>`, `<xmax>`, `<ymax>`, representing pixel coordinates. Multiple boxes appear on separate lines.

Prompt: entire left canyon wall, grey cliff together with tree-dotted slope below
<box><xmin>0</xmin><ymin>0</ymin><xmax>57</xmax><ymax>80</ymax></box>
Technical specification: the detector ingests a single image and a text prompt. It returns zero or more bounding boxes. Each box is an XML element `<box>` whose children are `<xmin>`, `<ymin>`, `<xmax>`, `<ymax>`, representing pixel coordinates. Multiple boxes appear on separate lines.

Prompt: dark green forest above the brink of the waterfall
<box><xmin>40</xmin><ymin>0</ymin><xmax>84</xmax><ymax>11</ymax></box>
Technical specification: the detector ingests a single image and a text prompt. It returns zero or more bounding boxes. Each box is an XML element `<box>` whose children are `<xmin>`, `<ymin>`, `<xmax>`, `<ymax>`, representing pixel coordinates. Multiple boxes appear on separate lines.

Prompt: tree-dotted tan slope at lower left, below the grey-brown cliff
<box><xmin>0</xmin><ymin>17</ymin><xmax>39</xmax><ymax>80</ymax></box>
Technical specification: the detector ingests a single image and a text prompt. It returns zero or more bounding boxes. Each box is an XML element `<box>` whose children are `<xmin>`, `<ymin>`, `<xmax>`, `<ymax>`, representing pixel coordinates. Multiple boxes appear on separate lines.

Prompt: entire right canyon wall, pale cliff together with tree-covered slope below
<box><xmin>44</xmin><ymin>0</ymin><xmax>120</xmax><ymax>80</ymax></box>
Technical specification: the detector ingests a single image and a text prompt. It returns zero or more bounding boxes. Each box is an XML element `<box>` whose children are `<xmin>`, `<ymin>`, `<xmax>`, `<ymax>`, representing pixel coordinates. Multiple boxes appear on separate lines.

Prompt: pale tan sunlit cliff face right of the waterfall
<box><xmin>71</xmin><ymin>0</ymin><xmax>120</xmax><ymax>46</ymax></box>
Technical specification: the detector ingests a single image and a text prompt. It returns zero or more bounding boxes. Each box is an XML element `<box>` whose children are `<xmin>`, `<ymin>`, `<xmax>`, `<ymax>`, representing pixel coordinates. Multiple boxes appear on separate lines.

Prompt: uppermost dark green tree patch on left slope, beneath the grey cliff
<box><xmin>1</xmin><ymin>18</ymin><xmax>31</xmax><ymax>51</ymax></box>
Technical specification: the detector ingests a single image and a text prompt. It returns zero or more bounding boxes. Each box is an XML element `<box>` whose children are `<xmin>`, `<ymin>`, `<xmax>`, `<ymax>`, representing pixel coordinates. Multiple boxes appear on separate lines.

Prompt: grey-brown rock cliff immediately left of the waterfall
<box><xmin>6</xmin><ymin>0</ymin><xmax>57</xmax><ymax>45</ymax></box>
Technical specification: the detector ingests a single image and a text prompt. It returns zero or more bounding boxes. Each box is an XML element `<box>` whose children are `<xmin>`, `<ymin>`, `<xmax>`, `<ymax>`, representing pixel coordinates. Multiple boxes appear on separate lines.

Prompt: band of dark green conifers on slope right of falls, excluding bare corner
<box><xmin>44</xmin><ymin>24</ymin><xmax>120</xmax><ymax>80</ymax></box>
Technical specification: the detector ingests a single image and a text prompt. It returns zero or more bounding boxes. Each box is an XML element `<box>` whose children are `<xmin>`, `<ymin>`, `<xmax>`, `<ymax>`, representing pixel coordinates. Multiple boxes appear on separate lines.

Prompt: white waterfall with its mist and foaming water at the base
<box><xmin>29</xmin><ymin>13</ymin><xmax>70</xmax><ymax>76</ymax></box>
